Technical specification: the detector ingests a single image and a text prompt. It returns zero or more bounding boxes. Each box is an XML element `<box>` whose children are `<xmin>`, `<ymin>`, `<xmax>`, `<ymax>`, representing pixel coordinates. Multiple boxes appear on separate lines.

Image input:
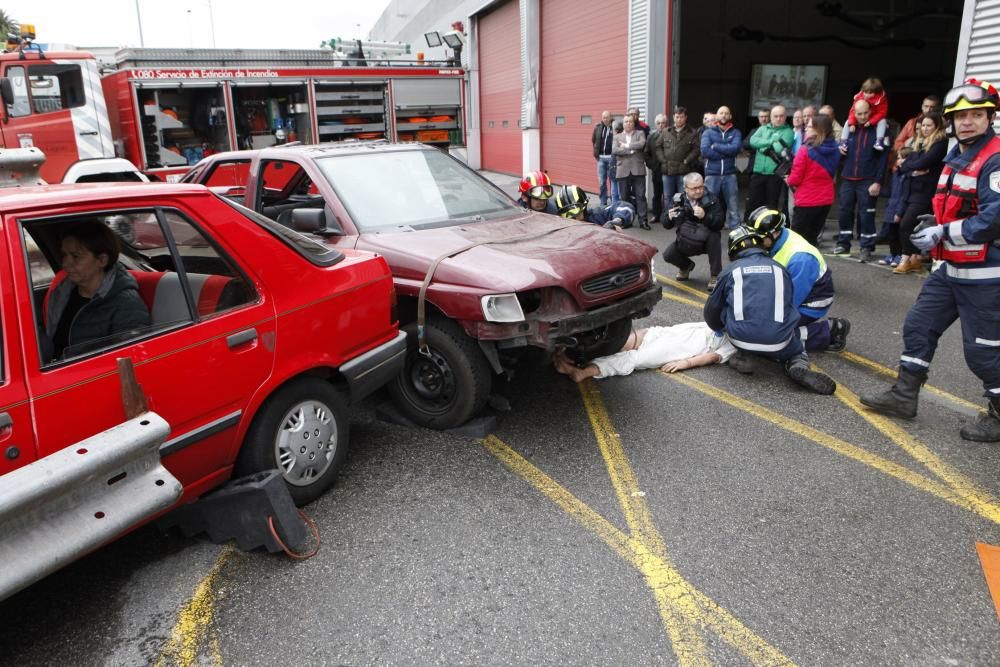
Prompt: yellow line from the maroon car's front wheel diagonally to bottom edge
<box><xmin>480</xmin><ymin>435</ymin><xmax>794</xmax><ymax>665</ymax></box>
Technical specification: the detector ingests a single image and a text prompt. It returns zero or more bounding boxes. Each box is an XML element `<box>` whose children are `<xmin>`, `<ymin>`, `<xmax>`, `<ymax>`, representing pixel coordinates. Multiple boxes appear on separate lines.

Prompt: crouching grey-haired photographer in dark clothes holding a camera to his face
<box><xmin>663</xmin><ymin>172</ymin><xmax>725</xmax><ymax>292</ymax></box>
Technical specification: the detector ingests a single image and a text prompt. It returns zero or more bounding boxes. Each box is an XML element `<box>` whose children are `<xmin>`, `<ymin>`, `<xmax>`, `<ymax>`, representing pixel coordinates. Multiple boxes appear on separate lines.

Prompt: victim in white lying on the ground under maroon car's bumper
<box><xmin>553</xmin><ymin>322</ymin><xmax>736</xmax><ymax>382</ymax></box>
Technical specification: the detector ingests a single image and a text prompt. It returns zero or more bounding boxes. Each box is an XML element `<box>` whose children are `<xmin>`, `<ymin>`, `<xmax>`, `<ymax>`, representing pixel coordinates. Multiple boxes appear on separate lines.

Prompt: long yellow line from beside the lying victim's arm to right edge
<box><xmin>657</xmin><ymin>371</ymin><xmax>993</xmax><ymax>521</ymax></box>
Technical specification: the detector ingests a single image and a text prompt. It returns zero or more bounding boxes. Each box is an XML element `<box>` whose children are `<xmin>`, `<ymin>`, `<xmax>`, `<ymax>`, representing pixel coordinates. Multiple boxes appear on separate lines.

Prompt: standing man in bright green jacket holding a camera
<box><xmin>746</xmin><ymin>104</ymin><xmax>795</xmax><ymax>214</ymax></box>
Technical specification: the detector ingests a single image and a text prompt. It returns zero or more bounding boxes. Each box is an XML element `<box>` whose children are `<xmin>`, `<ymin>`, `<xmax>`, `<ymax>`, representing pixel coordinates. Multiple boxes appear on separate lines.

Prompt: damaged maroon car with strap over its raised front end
<box><xmin>184</xmin><ymin>142</ymin><xmax>661</xmax><ymax>428</ymax></box>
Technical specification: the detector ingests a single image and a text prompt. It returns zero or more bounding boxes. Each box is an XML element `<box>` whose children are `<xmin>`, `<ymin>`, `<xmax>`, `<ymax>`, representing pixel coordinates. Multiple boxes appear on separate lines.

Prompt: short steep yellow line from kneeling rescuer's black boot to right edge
<box><xmin>820</xmin><ymin>368</ymin><xmax>1000</xmax><ymax>524</ymax></box>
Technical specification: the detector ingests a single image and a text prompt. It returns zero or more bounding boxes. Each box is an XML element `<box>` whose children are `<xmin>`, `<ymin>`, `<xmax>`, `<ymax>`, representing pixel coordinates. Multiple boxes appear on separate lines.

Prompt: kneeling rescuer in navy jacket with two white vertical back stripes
<box><xmin>704</xmin><ymin>226</ymin><xmax>837</xmax><ymax>395</ymax></box>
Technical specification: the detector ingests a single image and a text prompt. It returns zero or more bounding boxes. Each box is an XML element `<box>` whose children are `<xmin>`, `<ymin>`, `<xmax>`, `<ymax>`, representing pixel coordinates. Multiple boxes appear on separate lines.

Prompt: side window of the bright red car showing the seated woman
<box><xmin>23</xmin><ymin>209</ymin><xmax>257</xmax><ymax>366</ymax></box>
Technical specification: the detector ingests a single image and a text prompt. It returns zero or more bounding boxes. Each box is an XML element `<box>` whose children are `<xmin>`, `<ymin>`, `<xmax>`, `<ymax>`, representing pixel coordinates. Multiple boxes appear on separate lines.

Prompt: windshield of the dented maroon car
<box><xmin>316</xmin><ymin>149</ymin><xmax>517</xmax><ymax>232</ymax></box>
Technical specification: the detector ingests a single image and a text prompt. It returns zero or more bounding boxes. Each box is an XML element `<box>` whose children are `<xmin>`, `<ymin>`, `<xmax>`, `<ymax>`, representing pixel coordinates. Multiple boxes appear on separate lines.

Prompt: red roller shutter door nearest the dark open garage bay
<box><xmin>541</xmin><ymin>0</ymin><xmax>628</xmax><ymax>192</ymax></box>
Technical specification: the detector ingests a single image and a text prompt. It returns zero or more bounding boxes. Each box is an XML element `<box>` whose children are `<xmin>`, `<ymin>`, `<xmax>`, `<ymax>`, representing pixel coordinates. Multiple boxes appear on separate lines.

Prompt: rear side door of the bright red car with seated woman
<box><xmin>19</xmin><ymin>194</ymin><xmax>275</xmax><ymax>494</ymax></box>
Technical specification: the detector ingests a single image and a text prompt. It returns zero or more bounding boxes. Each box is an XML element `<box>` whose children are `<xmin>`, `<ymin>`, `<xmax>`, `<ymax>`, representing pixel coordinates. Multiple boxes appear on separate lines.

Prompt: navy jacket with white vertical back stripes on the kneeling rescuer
<box><xmin>705</xmin><ymin>248</ymin><xmax>799</xmax><ymax>353</ymax></box>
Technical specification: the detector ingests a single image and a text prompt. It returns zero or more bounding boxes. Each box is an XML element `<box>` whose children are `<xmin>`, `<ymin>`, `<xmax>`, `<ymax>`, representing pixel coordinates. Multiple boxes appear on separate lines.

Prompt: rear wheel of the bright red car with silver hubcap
<box><xmin>235</xmin><ymin>377</ymin><xmax>350</xmax><ymax>507</ymax></box>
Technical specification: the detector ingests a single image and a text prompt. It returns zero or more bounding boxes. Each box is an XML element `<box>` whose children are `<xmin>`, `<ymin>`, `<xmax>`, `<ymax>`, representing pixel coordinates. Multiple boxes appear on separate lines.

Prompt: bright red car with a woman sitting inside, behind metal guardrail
<box><xmin>0</xmin><ymin>184</ymin><xmax>406</xmax><ymax>597</ymax></box>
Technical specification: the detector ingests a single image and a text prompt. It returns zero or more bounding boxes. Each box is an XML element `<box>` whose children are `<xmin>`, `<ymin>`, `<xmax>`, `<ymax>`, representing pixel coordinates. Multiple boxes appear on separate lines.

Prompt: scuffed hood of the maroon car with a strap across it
<box><xmin>357</xmin><ymin>213</ymin><xmax>656</xmax><ymax>292</ymax></box>
